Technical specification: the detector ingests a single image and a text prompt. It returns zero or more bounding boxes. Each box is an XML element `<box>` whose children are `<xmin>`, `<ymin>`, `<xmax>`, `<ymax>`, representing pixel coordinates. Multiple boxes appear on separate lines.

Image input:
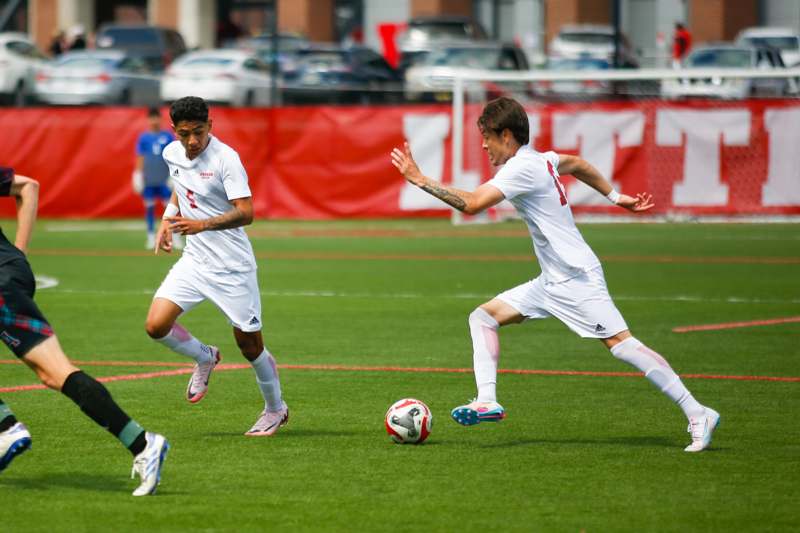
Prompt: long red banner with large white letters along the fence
<box><xmin>0</xmin><ymin>99</ymin><xmax>800</xmax><ymax>219</ymax></box>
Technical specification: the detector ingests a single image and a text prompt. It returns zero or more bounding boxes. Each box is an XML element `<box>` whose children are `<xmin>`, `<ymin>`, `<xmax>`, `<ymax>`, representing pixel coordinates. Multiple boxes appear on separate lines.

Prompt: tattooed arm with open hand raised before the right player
<box><xmin>391</xmin><ymin>143</ymin><xmax>504</xmax><ymax>215</ymax></box>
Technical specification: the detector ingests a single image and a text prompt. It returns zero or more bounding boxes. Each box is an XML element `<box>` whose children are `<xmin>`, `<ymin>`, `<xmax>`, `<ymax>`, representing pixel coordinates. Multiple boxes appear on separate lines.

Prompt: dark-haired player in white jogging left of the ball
<box><xmin>145</xmin><ymin>96</ymin><xmax>289</xmax><ymax>436</ymax></box>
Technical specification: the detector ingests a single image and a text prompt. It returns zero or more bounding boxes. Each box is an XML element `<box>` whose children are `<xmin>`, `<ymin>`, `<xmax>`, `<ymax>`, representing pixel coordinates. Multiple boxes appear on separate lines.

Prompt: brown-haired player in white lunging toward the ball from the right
<box><xmin>391</xmin><ymin>97</ymin><xmax>720</xmax><ymax>452</ymax></box>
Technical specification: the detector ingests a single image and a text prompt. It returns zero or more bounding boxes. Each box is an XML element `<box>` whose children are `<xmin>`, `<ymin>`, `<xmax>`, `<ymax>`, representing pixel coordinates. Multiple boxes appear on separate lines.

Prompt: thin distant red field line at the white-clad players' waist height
<box><xmin>30</xmin><ymin>248</ymin><xmax>800</xmax><ymax>265</ymax></box>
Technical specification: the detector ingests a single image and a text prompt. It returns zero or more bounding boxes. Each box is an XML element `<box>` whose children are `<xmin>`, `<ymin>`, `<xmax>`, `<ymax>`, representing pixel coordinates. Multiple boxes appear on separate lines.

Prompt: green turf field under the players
<box><xmin>0</xmin><ymin>221</ymin><xmax>800</xmax><ymax>532</ymax></box>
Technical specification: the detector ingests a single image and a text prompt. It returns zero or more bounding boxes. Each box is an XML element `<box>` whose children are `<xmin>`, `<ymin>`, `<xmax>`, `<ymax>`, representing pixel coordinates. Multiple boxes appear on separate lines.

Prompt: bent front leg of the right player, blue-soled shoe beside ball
<box><xmin>450</xmin><ymin>280</ymin><xmax>547</xmax><ymax>426</ymax></box>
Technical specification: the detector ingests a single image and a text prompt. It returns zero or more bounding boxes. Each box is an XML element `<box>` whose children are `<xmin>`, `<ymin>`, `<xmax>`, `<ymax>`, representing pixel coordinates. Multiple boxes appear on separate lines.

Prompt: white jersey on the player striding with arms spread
<box><xmin>488</xmin><ymin>146</ymin><xmax>600</xmax><ymax>282</ymax></box>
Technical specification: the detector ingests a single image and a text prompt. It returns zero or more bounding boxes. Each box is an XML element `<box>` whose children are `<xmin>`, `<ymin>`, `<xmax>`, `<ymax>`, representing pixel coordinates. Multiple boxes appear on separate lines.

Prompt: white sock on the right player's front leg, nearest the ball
<box><xmin>469</xmin><ymin>307</ymin><xmax>500</xmax><ymax>402</ymax></box>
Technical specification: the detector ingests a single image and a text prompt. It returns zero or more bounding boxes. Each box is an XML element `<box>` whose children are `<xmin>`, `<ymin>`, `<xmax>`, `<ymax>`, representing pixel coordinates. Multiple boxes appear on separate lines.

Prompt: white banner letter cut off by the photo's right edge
<box><xmin>761</xmin><ymin>108</ymin><xmax>800</xmax><ymax>206</ymax></box>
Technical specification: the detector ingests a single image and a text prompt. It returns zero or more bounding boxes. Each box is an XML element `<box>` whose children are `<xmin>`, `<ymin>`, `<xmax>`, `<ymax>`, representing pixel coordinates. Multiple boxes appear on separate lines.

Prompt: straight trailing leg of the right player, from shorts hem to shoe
<box><xmin>601</xmin><ymin>330</ymin><xmax>720</xmax><ymax>452</ymax></box>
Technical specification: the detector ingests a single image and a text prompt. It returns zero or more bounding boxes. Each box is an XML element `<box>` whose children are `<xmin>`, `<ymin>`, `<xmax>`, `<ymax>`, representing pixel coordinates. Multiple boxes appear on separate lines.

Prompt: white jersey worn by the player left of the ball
<box><xmin>163</xmin><ymin>136</ymin><xmax>256</xmax><ymax>272</ymax></box>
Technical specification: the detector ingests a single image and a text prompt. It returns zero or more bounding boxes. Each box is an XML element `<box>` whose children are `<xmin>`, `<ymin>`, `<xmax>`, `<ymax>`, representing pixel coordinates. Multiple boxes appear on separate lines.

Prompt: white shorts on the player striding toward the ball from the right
<box><xmin>496</xmin><ymin>267</ymin><xmax>628</xmax><ymax>339</ymax></box>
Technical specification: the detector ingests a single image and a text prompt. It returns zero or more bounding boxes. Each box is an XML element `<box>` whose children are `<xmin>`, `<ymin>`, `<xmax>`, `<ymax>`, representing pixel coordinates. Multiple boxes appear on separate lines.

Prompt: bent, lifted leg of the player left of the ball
<box><xmin>145</xmin><ymin>258</ymin><xmax>222</xmax><ymax>403</ymax></box>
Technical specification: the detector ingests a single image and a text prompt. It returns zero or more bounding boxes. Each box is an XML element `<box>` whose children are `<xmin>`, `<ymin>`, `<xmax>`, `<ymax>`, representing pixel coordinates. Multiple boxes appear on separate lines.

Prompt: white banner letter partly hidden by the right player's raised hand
<box><xmin>400</xmin><ymin>113</ymin><xmax>450</xmax><ymax>211</ymax></box>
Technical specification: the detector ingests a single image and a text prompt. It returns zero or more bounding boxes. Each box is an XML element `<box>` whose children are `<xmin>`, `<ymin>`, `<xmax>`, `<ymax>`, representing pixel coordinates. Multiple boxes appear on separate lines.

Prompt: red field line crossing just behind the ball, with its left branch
<box><xmin>0</xmin><ymin>360</ymin><xmax>800</xmax><ymax>393</ymax></box>
